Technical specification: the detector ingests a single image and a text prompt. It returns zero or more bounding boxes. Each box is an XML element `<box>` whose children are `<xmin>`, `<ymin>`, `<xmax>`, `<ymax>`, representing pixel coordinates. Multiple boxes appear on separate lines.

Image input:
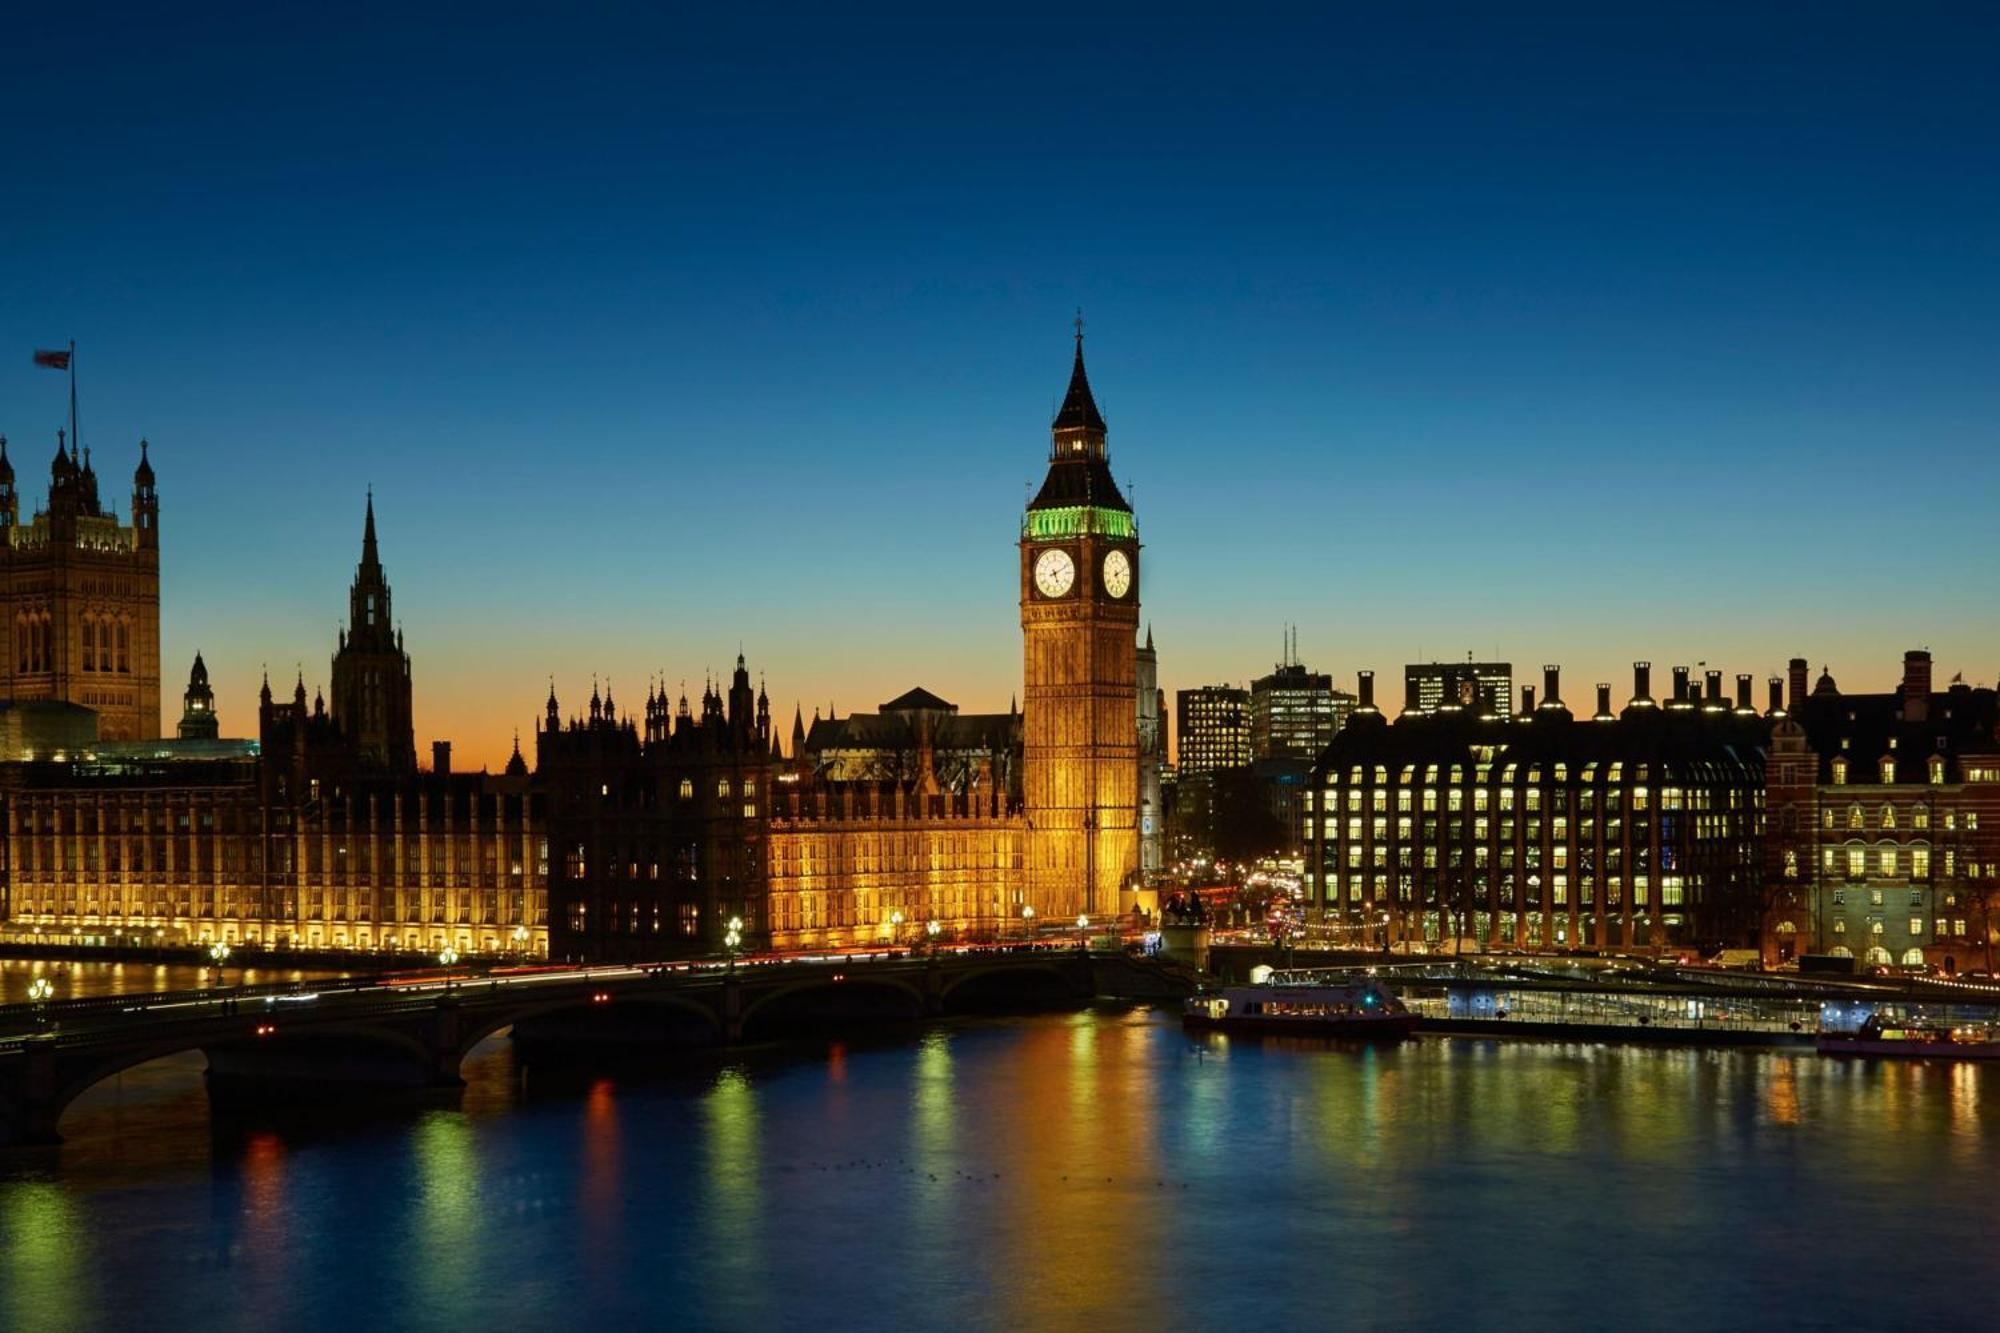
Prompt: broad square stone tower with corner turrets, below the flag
<box><xmin>0</xmin><ymin>436</ymin><xmax>160</xmax><ymax>741</ymax></box>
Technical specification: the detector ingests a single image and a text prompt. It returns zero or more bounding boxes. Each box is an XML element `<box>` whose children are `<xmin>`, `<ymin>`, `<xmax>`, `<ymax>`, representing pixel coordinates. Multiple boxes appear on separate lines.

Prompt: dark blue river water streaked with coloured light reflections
<box><xmin>0</xmin><ymin>992</ymin><xmax>2000</xmax><ymax>1329</ymax></box>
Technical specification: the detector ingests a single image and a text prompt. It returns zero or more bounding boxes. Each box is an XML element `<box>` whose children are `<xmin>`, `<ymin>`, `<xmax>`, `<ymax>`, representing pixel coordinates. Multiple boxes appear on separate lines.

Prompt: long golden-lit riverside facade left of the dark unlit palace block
<box><xmin>0</xmin><ymin>500</ymin><xmax>548</xmax><ymax>955</ymax></box>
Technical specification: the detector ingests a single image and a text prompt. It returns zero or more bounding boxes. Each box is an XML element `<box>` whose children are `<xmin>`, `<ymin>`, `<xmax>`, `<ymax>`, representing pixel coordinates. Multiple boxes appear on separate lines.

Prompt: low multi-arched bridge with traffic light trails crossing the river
<box><xmin>0</xmin><ymin>947</ymin><xmax>1194</xmax><ymax>1147</ymax></box>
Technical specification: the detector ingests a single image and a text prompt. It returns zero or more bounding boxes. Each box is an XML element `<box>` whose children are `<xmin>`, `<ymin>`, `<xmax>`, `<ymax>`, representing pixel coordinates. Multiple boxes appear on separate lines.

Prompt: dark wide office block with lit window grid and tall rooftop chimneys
<box><xmin>1304</xmin><ymin>664</ymin><xmax>1768</xmax><ymax>949</ymax></box>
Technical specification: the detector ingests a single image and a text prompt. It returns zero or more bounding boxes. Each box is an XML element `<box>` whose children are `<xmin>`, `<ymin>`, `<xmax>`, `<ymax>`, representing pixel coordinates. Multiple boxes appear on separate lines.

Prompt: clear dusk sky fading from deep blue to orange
<box><xmin>0</xmin><ymin>4</ymin><xmax>2000</xmax><ymax>761</ymax></box>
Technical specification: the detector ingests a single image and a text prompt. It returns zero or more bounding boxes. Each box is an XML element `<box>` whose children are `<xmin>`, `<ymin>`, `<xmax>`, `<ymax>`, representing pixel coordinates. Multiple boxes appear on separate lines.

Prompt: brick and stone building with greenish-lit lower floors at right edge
<box><xmin>1764</xmin><ymin>650</ymin><xmax>2000</xmax><ymax>973</ymax></box>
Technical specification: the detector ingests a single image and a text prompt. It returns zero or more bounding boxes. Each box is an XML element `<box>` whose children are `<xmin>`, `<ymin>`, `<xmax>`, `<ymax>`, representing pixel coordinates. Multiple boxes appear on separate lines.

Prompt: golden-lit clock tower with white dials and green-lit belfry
<box><xmin>1020</xmin><ymin>326</ymin><xmax>1138</xmax><ymax>919</ymax></box>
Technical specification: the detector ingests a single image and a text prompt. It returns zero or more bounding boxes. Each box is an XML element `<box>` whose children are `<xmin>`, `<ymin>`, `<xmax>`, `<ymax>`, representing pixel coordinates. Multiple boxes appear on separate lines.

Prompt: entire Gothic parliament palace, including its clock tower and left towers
<box><xmin>0</xmin><ymin>334</ymin><xmax>1164</xmax><ymax>961</ymax></box>
